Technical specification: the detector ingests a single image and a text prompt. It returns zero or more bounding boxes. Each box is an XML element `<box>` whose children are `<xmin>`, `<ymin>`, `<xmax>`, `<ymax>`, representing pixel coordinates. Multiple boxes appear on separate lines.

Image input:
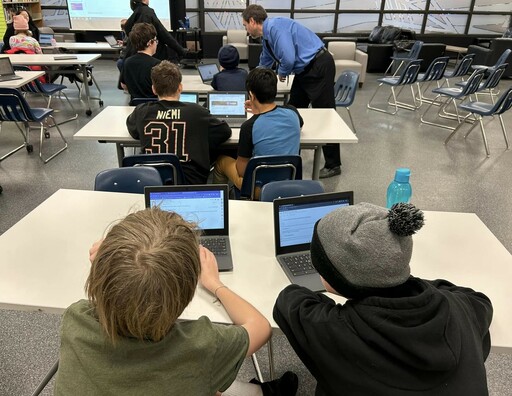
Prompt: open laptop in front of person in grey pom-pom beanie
<box><xmin>274</xmin><ymin>191</ymin><xmax>354</xmax><ymax>291</ymax></box>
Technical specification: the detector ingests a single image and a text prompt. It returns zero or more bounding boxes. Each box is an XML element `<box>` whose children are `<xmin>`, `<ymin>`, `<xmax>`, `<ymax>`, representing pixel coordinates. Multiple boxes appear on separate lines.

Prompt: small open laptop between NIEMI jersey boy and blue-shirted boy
<box><xmin>208</xmin><ymin>91</ymin><xmax>247</xmax><ymax>128</ymax></box>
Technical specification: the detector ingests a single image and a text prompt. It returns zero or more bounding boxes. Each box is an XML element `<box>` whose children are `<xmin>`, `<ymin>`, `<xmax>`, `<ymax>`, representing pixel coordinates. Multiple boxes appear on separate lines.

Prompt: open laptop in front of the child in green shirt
<box><xmin>144</xmin><ymin>184</ymin><xmax>233</xmax><ymax>271</ymax></box>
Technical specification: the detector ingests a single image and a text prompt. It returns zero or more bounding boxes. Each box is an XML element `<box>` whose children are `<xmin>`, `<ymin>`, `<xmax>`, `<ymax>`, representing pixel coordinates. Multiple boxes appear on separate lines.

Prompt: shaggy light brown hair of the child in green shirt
<box><xmin>85</xmin><ymin>207</ymin><xmax>201</xmax><ymax>344</ymax></box>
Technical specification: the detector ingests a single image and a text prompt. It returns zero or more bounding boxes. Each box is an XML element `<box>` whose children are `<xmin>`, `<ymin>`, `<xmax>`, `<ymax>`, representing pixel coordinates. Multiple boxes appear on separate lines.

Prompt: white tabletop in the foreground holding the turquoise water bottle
<box><xmin>0</xmin><ymin>190</ymin><xmax>512</xmax><ymax>352</ymax></box>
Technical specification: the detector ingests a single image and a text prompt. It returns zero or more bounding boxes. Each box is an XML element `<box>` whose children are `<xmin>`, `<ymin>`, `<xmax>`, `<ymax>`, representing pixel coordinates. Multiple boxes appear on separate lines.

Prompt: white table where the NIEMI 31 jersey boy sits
<box><xmin>74</xmin><ymin>106</ymin><xmax>358</xmax><ymax>180</ymax></box>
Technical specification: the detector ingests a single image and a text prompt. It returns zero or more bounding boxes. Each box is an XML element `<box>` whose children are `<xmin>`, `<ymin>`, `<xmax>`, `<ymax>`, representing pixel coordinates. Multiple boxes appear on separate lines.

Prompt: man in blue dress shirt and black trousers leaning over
<box><xmin>242</xmin><ymin>4</ymin><xmax>341</xmax><ymax>178</ymax></box>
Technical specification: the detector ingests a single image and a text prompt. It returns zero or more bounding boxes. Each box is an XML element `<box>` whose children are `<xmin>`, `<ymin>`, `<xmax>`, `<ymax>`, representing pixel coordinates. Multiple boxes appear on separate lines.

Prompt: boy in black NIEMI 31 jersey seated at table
<box><xmin>126</xmin><ymin>58</ymin><xmax>231</xmax><ymax>184</ymax></box>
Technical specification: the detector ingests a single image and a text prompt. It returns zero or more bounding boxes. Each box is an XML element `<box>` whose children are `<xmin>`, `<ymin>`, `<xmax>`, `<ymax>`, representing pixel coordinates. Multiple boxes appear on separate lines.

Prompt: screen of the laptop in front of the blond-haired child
<box><xmin>145</xmin><ymin>185</ymin><xmax>228</xmax><ymax>235</ymax></box>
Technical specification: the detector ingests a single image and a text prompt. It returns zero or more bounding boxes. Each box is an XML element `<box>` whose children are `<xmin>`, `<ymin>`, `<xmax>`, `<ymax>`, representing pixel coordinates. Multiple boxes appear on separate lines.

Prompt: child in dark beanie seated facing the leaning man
<box><xmin>212</xmin><ymin>45</ymin><xmax>247</xmax><ymax>91</ymax></box>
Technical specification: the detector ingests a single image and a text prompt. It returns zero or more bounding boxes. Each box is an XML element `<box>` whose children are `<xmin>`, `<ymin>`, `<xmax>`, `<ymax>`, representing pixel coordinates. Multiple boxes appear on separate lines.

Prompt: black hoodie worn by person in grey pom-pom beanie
<box><xmin>274</xmin><ymin>277</ymin><xmax>492</xmax><ymax>396</ymax></box>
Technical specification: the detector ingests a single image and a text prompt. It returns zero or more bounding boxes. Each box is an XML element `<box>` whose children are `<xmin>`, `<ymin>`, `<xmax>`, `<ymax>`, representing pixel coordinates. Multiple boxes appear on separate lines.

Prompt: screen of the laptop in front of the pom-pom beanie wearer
<box><xmin>274</xmin><ymin>191</ymin><xmax>353</xmax><ymax>254</ymax></box>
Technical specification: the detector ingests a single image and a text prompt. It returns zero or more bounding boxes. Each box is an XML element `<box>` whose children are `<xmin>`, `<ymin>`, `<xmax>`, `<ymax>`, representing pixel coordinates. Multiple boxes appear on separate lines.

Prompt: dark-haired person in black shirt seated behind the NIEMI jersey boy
<box><xmin>121</xmin><ymin>23</ymin><xmax>160</xmax><ymax>100</ymax></box>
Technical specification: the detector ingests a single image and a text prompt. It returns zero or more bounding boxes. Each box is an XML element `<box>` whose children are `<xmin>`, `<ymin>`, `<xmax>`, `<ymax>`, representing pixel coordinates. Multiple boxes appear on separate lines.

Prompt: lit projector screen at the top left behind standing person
<box><xmin>68</xmin><ymin>0</ymin><xmax>171</xmax><ymax>31</ymax></box>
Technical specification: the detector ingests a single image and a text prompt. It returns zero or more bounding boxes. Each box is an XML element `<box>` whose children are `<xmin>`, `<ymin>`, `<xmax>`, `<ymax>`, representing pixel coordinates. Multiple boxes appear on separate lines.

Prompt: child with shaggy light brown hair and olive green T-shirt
<box><xmin>54</xmin><ymin>207</ymin><xmax>297</xmax><ymax>396</ymax></box>
